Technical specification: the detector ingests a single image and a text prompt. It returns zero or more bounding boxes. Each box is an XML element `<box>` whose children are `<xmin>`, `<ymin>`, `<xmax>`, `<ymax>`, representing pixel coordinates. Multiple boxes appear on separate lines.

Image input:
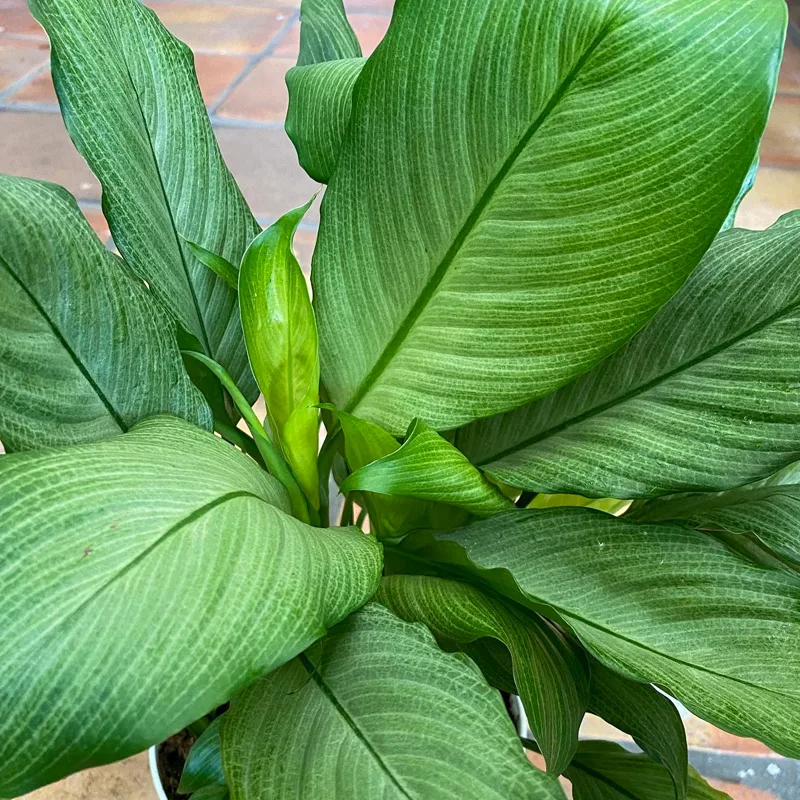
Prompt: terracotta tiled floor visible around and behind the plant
<box><xmin>0</xmin><ymin>0</ymin><xmax>800</xmax><ymax>800</ymax></box>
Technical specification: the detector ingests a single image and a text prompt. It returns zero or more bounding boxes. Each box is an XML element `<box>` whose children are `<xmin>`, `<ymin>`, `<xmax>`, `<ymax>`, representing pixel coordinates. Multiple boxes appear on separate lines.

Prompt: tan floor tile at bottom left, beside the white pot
<box><xmin>23</xmin><ymin>753</ymin><xmax>157</xmax><ymax>800</ymax></box>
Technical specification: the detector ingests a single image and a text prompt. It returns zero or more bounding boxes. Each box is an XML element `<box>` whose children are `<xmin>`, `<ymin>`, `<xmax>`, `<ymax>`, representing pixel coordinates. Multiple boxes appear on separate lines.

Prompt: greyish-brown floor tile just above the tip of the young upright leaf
<box><xmin>216</xmin><ymin>127</ymin><xmax>320</xmax><ymax>222</ymax></box>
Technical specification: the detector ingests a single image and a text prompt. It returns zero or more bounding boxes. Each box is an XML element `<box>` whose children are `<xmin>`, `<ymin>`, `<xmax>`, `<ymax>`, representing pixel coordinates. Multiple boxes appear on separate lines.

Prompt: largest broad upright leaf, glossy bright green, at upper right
<box><xmin>312</xmin><ymin>0</ymin><xmax>786</xmax><ymax>434</ymax></box>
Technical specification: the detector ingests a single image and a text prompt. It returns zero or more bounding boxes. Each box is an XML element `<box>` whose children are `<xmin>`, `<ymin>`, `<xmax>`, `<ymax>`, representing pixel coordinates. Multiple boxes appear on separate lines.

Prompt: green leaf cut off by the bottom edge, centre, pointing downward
<box><xmin>222</xmin><ymin>604</ymin><xmax>563</xmax><ymax>800</ymax></box>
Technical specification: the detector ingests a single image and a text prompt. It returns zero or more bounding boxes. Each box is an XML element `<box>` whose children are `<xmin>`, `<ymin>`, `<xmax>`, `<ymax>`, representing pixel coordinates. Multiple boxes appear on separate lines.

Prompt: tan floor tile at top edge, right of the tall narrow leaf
<box><xmin>147</xmin><ymin>0</ymin><xmax>294</xmax><ymax>54</ymax></box>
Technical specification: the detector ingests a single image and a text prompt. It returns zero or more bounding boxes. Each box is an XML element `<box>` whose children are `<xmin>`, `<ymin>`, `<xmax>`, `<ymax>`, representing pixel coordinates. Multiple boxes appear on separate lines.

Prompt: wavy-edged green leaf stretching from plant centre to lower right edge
<box><xmin>404</xmin><ymin>509</ymin><xmax>800</xmax><ymax>758</ymax></box>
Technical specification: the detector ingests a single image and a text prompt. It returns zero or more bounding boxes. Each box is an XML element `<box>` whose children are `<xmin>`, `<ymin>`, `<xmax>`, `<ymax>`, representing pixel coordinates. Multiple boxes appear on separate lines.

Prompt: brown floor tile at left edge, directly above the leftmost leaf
<box><xmin>0</xmin><ymin>111</ymin><xmax>100</xmax><ymax>200</ymax></box>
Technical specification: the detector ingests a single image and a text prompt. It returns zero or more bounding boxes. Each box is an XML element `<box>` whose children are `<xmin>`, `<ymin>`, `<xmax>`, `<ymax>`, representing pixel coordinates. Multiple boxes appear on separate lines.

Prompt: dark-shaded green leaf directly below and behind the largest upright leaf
<box><xmin>457</xmin><ymin>212</ymin><xmax>800</xmax><ymax>498</ymax></box>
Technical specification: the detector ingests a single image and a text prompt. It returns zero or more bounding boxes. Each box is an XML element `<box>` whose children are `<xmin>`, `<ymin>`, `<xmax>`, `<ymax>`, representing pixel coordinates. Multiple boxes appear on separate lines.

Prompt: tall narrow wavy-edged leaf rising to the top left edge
<box><xmin>30</xmin><ymin>0</ymin><xmax>260</xmax><ymax>401</ymax></box>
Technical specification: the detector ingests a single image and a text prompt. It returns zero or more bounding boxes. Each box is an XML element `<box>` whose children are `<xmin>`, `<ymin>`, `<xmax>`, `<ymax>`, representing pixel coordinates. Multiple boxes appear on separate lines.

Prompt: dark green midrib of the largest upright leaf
<box><xmin>344</xmin><ymin>21</ymin><xmax>612</xmax><ymax>413</ymax></box>
